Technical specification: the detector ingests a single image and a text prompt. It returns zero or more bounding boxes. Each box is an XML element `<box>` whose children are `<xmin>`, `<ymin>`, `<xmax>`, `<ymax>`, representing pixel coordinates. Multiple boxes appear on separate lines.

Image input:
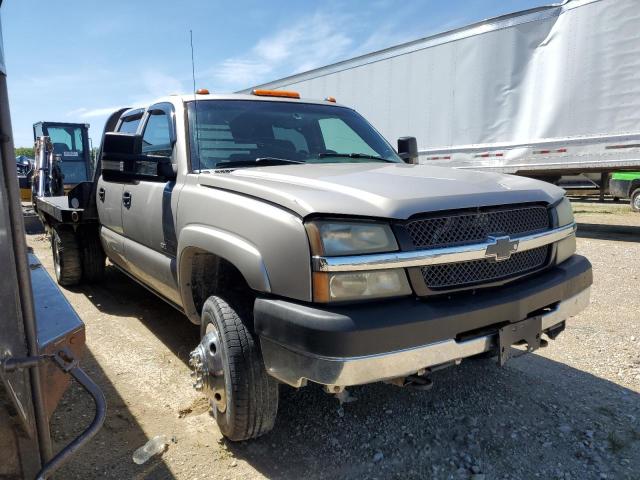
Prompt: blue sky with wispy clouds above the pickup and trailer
<box><xmin>2</xmin><ymin>0</ymin><xmax>551</xmax><ymax>146</ymax></box>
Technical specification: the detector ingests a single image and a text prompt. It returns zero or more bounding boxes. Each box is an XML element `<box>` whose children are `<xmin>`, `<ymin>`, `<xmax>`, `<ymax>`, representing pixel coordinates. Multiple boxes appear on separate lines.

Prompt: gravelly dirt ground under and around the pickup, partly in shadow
<box><xmin>28</xmin><ymin>201</ymin><xmax>640</xmax><ymax>480</ymax></box>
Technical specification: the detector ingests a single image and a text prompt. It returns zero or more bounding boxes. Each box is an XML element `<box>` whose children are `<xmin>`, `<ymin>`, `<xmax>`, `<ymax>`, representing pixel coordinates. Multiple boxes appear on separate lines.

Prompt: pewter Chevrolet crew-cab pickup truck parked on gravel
<box><xmin>47</xmin><ymin>91</ymin><xmax>592</xmax><ymax>440</ymax></box>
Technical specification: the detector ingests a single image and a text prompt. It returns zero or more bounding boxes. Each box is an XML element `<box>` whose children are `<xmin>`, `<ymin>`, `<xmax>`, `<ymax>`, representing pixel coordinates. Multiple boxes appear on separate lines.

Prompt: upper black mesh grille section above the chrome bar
<box><xmin>405</xmin><ymin>205</ymin><xmax>550</xmax><ymax>249</ymax></box>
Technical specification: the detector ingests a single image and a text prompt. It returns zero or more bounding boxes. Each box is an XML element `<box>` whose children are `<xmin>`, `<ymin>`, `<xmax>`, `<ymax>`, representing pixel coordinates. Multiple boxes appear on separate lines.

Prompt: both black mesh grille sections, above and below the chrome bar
<box><xmin>404</xmin><ymin>205</ymin><xmax>551</xmax><ymax>294</ymax></box>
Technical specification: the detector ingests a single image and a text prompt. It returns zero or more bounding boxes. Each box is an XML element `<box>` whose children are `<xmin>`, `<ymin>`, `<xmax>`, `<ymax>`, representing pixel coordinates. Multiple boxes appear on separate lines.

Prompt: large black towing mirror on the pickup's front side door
<box><xmin>101</xmin><ymin>132</ymin><xmax>176</xmax><ymax>181</ymax></box>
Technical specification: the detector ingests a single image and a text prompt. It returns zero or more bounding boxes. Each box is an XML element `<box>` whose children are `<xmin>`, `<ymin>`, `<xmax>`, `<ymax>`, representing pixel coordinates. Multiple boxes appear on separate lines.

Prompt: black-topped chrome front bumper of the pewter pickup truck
<box><xmin>254</xmin><ymin>255</ymin><xmax>592</xmax><ymax>387</ymax></box>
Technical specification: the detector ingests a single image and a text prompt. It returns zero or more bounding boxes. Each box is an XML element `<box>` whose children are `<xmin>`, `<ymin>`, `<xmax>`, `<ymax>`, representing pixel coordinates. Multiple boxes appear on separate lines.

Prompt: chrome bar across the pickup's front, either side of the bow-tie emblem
<box><xmin>312</xmin><ymin>222</ymin><xmax>576</xmax><ymax>272</ymax></box>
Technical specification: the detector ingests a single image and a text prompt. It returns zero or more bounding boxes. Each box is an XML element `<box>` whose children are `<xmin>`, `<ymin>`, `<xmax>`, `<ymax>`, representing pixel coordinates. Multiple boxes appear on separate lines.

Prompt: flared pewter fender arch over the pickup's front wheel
<box><xmin>177</xmin><ymin>225</ymin><xmax>271</xmax><ymax>323</ymax></box>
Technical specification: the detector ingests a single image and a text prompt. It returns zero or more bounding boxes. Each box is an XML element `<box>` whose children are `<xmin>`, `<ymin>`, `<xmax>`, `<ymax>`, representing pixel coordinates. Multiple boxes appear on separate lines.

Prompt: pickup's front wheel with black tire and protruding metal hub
<box><xmin>190</xmin><ymin>296</ymin><xmax>278</xmax><ymax>441</ymax></box>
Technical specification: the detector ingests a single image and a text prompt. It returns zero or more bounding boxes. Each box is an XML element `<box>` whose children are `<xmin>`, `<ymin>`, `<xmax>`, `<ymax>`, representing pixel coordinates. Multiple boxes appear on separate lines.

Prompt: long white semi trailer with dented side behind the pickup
<box><xmin>248</xmin><ymin>0</ymin><xmax>640</xmax><ymax>182</ymax></box>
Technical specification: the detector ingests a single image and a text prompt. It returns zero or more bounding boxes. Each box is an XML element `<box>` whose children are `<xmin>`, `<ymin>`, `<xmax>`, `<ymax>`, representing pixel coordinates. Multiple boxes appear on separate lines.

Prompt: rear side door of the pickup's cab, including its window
<box><xmin>96</xmin><ymin>109</ymin><xmax>144</xmax><ymax>267</ymax></box>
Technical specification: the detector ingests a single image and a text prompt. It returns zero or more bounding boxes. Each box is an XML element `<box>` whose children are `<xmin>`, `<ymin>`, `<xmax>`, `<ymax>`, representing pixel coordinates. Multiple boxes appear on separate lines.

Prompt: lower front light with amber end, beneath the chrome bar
<box><xmin>313</xmin><ymin>269</ymin><xmax>411</xmax><ymax>303</ymax></box>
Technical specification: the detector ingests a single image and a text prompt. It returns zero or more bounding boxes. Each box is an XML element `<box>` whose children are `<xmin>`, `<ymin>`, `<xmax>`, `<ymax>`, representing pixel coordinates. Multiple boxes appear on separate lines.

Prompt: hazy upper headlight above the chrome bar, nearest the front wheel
<box><xmin>307</xmin><ymin>221</ymin><xmax>398</xmax><ymax>257</ymax></box>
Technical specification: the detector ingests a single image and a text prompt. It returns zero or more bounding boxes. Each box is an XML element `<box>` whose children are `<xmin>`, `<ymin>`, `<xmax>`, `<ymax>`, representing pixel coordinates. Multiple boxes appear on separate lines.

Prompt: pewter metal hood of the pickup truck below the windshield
<box><xmin>198</xmin><ymin>163</ymin><xmax>564</xmax><ymax>219</ymax></box>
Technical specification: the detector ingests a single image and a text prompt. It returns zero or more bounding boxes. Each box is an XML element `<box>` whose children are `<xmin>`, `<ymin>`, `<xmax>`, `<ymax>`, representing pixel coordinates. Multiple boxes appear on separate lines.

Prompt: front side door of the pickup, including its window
<box><xmin>122</xmin><ymin>103</ymin><xmax>180</xmax><ymax>304</ymax></box>
